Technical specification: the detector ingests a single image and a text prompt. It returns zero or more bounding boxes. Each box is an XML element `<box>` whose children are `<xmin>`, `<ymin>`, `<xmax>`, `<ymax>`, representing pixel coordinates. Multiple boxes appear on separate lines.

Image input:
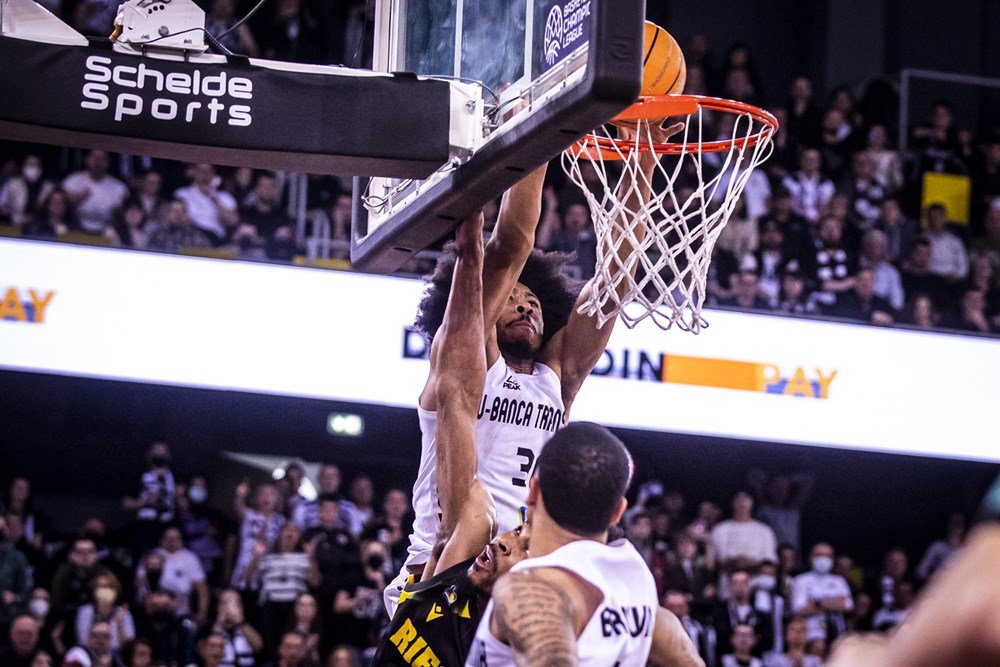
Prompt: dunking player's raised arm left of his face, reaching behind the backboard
<box><xmin>483</xmin><ymin>163</ymin><xmax>548</xmax><ymax>364</ymax></box>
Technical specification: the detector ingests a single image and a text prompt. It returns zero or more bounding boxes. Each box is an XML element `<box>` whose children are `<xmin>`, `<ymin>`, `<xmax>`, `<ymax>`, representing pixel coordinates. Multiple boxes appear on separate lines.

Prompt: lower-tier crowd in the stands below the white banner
<box><xmin>0</xmin><ymin>442</ymin><xmax>965</xmax><ymax>667</ymax></box>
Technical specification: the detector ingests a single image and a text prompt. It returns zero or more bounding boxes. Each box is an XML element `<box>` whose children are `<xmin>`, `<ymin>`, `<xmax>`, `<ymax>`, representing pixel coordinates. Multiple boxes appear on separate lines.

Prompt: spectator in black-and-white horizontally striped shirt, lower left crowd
<box><xmin>246</xmin><ymin>521</ymin><xmax>308</xmax><ymax>647</ymax></box>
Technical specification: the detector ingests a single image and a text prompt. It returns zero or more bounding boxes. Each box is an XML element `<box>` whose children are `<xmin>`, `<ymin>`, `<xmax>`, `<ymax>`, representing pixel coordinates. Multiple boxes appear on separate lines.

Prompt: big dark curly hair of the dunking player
<box><xmin>413</xmin><ymin>242</ymin><xmax>583</xmax><ymax>345</ymax></box>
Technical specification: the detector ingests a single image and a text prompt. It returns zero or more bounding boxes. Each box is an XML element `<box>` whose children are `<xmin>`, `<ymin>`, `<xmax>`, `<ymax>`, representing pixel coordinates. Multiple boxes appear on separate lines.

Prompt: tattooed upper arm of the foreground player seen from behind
<box><xmin>491</xmin><ymin>570</ymin><xmax>577</xmax><ymax>667</ymax></box>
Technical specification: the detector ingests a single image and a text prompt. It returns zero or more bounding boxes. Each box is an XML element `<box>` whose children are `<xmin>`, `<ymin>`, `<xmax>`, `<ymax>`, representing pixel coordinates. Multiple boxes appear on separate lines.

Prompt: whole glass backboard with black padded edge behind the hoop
<box><xmin>351</xmin><ymin>0</ymin><xmax>645</xmax><ymax>272</ymax></box>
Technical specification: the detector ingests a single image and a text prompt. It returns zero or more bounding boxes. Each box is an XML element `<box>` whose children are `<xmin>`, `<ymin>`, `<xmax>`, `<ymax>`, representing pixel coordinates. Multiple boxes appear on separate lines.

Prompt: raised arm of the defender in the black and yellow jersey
<box><xmin>424</xmin><ymin>212</ymin><xmax>495</xmax><ymax>578</ymax></box>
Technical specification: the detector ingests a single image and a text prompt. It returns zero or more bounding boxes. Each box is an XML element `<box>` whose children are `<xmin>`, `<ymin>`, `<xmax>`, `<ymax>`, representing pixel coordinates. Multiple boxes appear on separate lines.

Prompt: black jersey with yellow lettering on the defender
<box><xmin>372</xmin><ymin>558</ymin><xmax>488</xmax><ymax>667</ymax></box>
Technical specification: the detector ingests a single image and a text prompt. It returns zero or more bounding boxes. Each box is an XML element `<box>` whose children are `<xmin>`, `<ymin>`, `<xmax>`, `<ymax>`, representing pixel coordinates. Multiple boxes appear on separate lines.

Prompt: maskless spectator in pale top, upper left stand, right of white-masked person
<box><xmin>62</xmin><ymin>150</ymin><xmax>128</xmax><ymax>235</ymax></box>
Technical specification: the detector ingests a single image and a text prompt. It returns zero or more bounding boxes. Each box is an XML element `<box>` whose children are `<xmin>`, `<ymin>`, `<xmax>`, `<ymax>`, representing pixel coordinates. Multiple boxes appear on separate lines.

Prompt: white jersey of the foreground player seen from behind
<box><xmin>465</xmin><ymin>540</ymin><xmax>658</xmax><ymax>667</ymax></box>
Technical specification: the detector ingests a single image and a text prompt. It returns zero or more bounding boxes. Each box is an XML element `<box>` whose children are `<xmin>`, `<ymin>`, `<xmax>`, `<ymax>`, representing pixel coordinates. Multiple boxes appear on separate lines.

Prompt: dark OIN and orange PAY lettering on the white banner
<box><xmin>592</xmin><ymin>348</ymin><xmax>837</xmax><ymax>399</ymax></box>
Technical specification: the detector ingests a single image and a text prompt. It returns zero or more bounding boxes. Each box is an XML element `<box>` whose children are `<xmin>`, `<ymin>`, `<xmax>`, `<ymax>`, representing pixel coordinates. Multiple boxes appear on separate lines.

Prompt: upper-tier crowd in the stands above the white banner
<box><xmin>0</xmin><ymin>6</ymin><xmax>1000</xmax><ymax>334</ymax></box>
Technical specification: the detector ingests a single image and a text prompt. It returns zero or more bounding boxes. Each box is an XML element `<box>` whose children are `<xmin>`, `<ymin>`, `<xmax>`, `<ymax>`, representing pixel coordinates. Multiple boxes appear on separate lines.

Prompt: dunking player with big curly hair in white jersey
<box><xmin>385</xmin><ymin>124</ymin><xmax>683</xmax><ymax>615</ymax></box>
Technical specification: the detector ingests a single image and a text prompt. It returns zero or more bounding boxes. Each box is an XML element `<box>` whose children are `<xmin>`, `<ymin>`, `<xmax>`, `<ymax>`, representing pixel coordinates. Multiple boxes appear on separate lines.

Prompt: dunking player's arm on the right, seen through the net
<box><xmin>542</xmin><ymin>123</ymin><xmax>684</xmax><ymax>420</ymax></box>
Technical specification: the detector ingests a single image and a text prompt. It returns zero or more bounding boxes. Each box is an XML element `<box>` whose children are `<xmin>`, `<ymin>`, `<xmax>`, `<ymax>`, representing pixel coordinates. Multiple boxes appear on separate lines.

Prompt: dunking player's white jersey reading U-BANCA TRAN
<box><xmin>406</xmin><ymin>357</ymin><xmax>563</xmax><ymax>565</ymax></box>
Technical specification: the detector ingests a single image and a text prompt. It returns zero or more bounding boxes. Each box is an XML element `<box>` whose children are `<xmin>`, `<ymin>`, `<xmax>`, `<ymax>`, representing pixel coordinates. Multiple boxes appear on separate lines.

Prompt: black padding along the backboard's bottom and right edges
<box><xmin>351</xmin><ymin>0</ymin><xmax>646</xmax><ymax>273</ymax></box>
